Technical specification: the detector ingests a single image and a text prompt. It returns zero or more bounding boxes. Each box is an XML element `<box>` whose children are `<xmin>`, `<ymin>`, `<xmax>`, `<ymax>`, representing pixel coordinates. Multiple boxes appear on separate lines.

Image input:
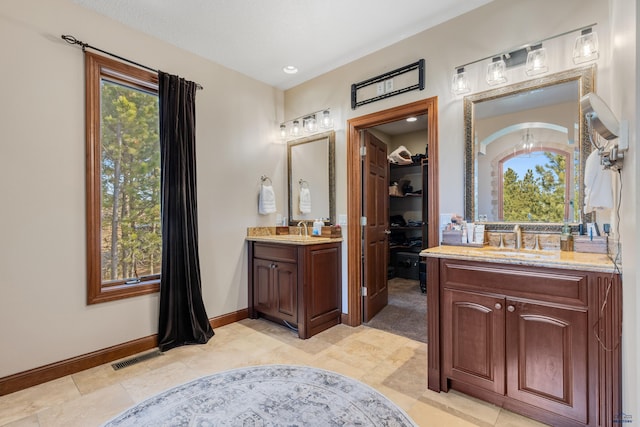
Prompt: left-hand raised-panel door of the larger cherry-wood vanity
<box><xmin>441</xmin><ymin>289</ymin><xmax>505</xmax><ymax>394</ymax></box>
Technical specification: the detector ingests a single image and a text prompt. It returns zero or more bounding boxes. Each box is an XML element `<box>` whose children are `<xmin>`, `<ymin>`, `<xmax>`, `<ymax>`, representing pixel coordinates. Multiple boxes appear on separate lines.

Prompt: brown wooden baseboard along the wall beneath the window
<box><xmin>0</xmin><ymin>308</ymin><xmax>249</xmax><ymax>396</ymax></box>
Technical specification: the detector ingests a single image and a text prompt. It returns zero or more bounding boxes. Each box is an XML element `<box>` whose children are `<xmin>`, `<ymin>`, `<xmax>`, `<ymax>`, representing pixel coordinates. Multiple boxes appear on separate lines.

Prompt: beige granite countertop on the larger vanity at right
<box><xmin>420</xmin><ymin>245</ymin><xmax>622</xmax><ymax>273</ymax></box>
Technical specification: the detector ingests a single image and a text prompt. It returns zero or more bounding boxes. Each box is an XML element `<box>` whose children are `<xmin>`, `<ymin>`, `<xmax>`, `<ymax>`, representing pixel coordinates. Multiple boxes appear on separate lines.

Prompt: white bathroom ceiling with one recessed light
<box><xmin>73</xmin><ymin>0</ymin><xmax>492</xmax><ymax>90</ymax></box>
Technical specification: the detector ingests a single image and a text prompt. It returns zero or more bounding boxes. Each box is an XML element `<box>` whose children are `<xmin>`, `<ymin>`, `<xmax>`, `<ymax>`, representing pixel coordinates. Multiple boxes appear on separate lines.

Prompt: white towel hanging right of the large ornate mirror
<box><xmin>584</xmin><ymin>150</ymin><xmax>613</xmax><ymax>213</ymax></box>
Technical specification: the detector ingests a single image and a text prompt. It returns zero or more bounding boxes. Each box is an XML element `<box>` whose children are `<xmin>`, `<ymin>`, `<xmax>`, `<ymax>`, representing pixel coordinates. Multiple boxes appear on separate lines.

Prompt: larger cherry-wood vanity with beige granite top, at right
<box><xmin>422</xmin><ymin>246</ymin><xmax>622</xmax><ymax>426</ymax></box>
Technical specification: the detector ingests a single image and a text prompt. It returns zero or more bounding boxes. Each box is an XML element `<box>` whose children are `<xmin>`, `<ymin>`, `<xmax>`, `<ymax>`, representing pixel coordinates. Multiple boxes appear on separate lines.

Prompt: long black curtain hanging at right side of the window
<box><xmin>158</xmin><ymin>71</ymin><xmax>214</xmax><ymax>351</ymax></box>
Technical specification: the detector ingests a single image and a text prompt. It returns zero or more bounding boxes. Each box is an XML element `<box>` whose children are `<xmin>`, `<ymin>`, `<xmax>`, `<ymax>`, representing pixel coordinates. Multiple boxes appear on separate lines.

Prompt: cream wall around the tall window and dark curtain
<box><xmin>0</xmin><ymin>0</ymin><xmax>286</xmax><ymax>377</ymax></box>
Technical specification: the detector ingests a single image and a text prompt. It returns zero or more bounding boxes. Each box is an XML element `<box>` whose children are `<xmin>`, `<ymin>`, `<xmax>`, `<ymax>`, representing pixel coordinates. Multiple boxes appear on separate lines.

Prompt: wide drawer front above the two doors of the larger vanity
<box><xmin>440</xmin><ymin>259</ymin><xmax>589</xmax><ymax>307</ymax></box>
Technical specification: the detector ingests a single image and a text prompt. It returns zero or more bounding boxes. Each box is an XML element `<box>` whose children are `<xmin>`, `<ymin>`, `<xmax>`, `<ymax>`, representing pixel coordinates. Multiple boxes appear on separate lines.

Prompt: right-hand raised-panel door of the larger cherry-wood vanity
<box><xmin>506</xmin><ymin>301</ymin><xmax>588</xmax><ymax>423</ymax></box>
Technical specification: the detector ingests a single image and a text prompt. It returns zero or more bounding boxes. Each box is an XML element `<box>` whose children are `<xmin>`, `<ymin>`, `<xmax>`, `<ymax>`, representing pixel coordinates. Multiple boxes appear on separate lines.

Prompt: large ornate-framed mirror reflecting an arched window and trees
<box><xmin>464</xmin><ymin>65</ymin><xmax>595</xmax><ymax>227</ymax></box>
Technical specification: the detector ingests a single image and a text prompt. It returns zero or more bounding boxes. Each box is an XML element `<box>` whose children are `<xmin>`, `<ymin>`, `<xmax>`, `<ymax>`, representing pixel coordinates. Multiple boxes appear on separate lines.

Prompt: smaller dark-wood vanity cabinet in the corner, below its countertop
<box><xmin>249</xmin><ymin>242</ymin><xmax>342</xmax><ymax>339</ymax></box>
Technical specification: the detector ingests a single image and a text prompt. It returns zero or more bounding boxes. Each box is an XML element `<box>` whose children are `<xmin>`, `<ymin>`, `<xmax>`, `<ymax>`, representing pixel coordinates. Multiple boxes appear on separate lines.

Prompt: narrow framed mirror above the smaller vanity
<box><xmin>287</xmin><ymin>131</ymin><xmax>336</xmax><ymax>225</ymax></box>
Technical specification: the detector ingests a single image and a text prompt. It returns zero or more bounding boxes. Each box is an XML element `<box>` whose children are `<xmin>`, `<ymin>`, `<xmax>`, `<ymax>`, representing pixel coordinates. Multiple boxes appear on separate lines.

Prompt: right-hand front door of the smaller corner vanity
<box><xmin>273</xmin><ymin>262</ymin><xmax>298</xmax><ymax>323</ymax></box>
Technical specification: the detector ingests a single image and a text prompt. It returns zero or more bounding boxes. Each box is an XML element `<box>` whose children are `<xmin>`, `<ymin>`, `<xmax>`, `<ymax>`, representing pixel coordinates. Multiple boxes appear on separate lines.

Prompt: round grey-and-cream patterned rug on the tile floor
<box><xmin>104</xmin><ymin>365</ymin><xmax>416</xmax><ymax>427</ymax></box>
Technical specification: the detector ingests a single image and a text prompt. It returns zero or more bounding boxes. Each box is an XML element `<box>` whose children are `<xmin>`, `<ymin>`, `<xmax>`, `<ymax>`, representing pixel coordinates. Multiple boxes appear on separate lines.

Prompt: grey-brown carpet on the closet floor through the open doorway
<box><xmin>366</xmin><ymin>278</ymin><xmax>427</xmax><ymax>343</ymax></box>
